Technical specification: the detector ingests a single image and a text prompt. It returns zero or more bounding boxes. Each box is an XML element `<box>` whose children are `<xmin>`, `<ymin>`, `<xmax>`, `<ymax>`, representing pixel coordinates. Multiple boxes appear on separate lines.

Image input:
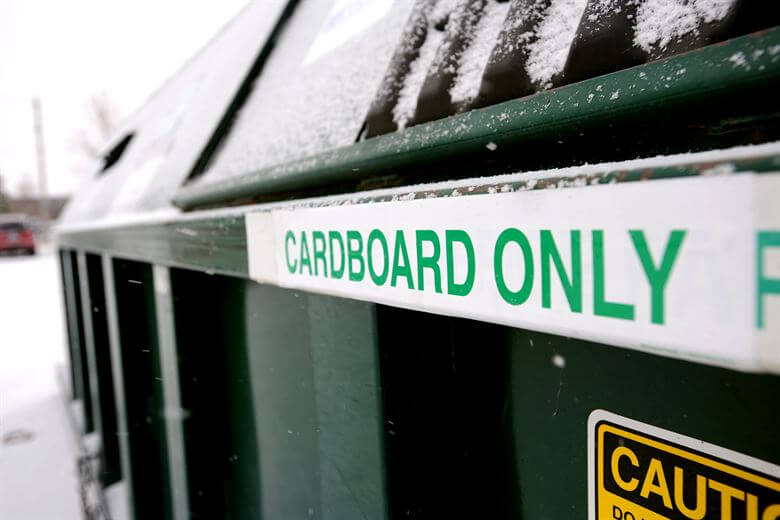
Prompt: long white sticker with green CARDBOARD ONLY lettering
<box><xmin>246</xmin><ymin>174</ymin><xmax>780</xmax><ymax>372</ymax></box>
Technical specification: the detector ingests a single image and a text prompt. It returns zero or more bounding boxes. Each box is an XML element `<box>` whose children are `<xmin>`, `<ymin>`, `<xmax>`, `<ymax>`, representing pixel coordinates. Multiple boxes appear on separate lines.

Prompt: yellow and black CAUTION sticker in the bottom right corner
<box><xmin>588</xmin><ymin>410</ymin><xmax>780</xmax><ymax>520</ymax></box>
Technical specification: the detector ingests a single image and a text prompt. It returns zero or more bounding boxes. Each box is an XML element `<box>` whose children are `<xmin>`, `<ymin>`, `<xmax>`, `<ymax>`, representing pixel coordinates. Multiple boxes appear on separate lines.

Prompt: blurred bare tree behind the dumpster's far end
<box><xmin>71</xmin><ymin>91</ymin><xmax>119</xmax><ymax>173</ymax></box>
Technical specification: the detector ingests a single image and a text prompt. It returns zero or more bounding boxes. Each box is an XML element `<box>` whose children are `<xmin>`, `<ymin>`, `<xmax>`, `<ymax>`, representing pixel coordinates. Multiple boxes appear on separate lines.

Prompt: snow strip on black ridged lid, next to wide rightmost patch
<box><xmin>525</xmin><ymin>0</ymin><xmax>588</xmax><ymax>88</ymax></box>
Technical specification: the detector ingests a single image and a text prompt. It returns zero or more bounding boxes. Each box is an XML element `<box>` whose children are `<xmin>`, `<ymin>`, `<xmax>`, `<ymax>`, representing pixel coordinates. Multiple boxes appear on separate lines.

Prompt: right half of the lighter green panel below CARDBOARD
<box><xmin>308</xmin><ymin>295</ymin><xmax>387</xmax><ymax>520</ymax></box>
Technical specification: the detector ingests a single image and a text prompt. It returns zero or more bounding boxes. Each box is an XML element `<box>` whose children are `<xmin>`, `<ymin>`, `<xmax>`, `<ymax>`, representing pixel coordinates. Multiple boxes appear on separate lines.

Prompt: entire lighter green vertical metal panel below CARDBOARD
<box><xmin>245</xmin><ymin>282</ymin><xmax>386</xmax><ymax>519</ymax></box>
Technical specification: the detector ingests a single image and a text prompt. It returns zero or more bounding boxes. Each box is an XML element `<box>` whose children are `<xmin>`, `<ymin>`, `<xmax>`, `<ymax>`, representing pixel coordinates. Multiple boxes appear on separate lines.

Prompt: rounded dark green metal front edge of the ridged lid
<box><xmin>174</xmin><ymin>28</ymin><xmax>780</xmax><ymax>209</ymax></box>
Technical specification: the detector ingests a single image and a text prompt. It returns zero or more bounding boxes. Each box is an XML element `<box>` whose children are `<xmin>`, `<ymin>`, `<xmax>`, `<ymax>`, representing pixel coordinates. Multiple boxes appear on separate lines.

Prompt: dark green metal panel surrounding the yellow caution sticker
<box><xmin>506</xmin><ymin>329</ymin><xmax>780</xmax><ymax>519</ymax></box>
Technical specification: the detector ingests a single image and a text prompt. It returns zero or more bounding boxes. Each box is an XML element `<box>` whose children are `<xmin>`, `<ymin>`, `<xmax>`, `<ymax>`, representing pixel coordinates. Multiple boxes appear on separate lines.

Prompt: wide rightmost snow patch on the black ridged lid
<box><xmin>634</xmin><ymin>0</ymin><xmax>736</xmax><ymax>52</ymax></box>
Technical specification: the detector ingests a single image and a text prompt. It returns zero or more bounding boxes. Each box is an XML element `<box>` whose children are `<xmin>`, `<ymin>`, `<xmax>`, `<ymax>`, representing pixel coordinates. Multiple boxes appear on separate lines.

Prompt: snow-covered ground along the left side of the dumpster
<box><xmin>0</xmin><ymin>253</ymin><xmax>82</xmax><ymax>520</ymax></box>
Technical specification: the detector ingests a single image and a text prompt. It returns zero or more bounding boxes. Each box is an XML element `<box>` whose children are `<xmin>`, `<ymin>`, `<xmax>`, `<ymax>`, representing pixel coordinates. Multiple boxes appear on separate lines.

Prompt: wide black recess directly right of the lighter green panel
<box><xmin>377</xmin><ymin>306</ymin><xmax>520</xmax><ymax>518</ymax></box>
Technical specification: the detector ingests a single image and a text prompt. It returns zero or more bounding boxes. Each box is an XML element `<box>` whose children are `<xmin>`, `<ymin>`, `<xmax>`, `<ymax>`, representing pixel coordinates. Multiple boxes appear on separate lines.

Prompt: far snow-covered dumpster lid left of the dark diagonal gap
<box><xmin>60</xmin><ymin>0</ymin><xmax>287</xmax><ymax>224</ymax></box>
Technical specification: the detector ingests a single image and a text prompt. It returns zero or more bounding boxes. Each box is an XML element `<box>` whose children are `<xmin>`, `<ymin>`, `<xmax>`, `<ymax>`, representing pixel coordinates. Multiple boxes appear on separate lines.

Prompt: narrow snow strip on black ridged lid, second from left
<box><xmin>450</xmin><ymin>0</ymin><xmax>512</xmax><ymax>103</ymax></box>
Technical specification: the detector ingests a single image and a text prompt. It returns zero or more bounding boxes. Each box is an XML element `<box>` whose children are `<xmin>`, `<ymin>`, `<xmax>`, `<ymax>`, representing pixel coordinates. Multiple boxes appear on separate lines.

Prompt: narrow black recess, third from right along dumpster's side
<box><xmin>113</xmin><ymin>259</ymin><xmax>173</xmax><ymax>520</ymax></box>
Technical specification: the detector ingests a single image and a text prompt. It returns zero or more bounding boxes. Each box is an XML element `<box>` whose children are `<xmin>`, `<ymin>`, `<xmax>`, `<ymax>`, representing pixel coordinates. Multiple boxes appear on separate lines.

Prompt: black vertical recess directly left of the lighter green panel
<box><xmin>170</xmin><ymin>269</ymin><xmax>260</xmax><ymax>519</ymax></box>
